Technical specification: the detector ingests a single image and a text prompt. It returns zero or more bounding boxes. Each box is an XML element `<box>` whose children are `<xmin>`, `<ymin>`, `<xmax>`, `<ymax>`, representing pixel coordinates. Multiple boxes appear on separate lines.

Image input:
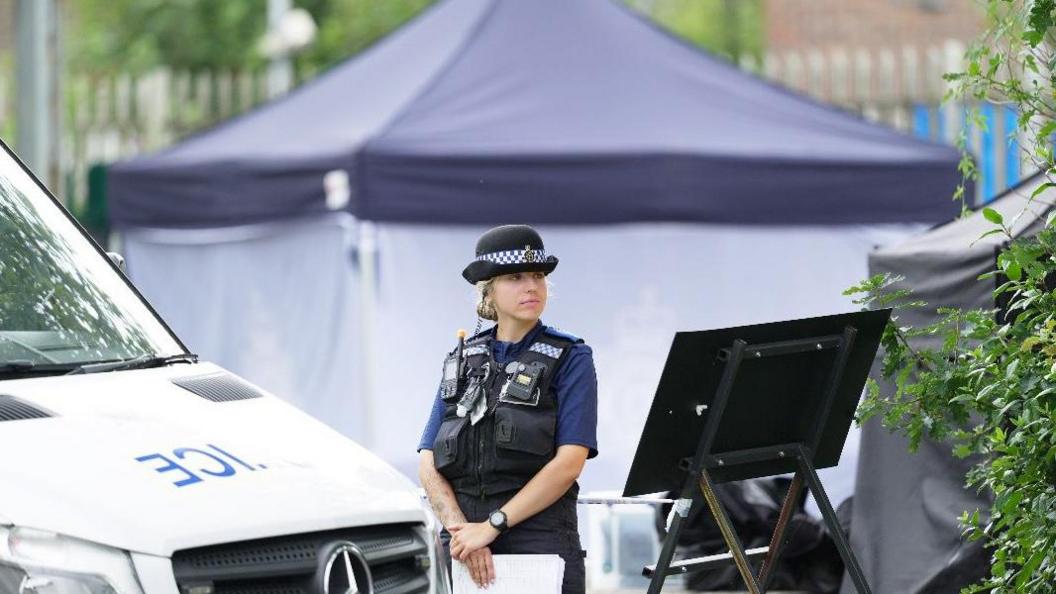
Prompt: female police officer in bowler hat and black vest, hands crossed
<box><xmin>418</xmin><ymin>225</ymin><xmax>598</xmax><ymax>594</ymax></box>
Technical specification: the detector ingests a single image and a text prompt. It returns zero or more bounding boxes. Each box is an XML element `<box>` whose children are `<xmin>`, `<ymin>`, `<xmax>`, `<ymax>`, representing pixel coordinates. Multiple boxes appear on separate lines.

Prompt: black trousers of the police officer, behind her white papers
<box><xmin>440</xmin><ymin>489</ymin><xmax>586</xmax><ymax>594</ymax></box>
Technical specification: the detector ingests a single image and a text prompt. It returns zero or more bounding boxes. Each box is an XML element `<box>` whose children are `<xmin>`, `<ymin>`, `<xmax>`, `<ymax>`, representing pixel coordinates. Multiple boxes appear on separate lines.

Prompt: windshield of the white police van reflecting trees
<box><xmin>0</xmin><ymin>145</ymin><xmax>185</xmax><ymax>369</ymax></box>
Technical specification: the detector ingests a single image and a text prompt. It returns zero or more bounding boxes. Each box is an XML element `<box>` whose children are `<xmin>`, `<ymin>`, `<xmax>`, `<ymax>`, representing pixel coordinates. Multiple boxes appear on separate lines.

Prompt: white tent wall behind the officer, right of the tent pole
<box><xmin>372</xmin><ymin>223</ymin><xmax>925</xmax><ymax>513</ymax></box>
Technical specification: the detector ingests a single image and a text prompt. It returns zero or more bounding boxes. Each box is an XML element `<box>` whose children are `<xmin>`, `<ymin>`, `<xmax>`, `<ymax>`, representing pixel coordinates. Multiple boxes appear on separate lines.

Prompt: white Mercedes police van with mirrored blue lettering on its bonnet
<box><xmin>0</xmin><ymin>142</ymin><xmax>447</xmax><ymax>594</ymax></box>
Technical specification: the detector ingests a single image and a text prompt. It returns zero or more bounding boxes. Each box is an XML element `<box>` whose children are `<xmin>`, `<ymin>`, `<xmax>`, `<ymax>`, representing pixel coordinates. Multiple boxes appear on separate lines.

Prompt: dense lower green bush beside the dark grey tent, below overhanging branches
<box><xmin>845</xmin><ymin>236</ymin><xmax>1056</xmax><ymax>593</ymax></box>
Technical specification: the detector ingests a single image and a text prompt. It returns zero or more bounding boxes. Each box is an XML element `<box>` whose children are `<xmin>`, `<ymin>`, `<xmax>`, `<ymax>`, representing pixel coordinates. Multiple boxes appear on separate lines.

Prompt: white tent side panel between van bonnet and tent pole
<box><xmin>121</xmin><ymin>215</ymin><xmax>366</xmax><ymax>439</ymax></box>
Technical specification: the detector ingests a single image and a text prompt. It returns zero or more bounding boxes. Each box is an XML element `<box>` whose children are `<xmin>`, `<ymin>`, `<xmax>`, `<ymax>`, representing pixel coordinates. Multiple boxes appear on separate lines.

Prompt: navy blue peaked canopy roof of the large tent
<box><xmin>110</xmin><ymin>0</ymin><xmax>959</xmax><ymax>227</ymax></box>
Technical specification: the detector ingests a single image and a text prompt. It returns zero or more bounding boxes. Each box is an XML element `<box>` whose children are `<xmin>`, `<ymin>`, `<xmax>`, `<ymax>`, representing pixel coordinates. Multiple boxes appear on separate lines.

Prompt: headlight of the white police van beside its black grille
<box><xmin>0</xmin><ymin>527</ymin><xmax>143</xmax><ymax>594</ymax></box>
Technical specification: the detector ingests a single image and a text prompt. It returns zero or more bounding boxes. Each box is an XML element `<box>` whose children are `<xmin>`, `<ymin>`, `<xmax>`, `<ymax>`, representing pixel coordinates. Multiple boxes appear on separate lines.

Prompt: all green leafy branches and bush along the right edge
<box><xmin>847</xmin><ymin>0</ymin><xmax>1056</xmax><ymax>594</ymax></box>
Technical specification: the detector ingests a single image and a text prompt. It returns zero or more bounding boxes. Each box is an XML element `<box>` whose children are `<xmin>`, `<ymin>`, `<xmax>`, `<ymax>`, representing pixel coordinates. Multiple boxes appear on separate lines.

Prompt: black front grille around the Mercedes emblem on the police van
<box><xmin>172</xmin><ymin>524</ymin><xmax>429</xmax><ymax>594</ymax></box>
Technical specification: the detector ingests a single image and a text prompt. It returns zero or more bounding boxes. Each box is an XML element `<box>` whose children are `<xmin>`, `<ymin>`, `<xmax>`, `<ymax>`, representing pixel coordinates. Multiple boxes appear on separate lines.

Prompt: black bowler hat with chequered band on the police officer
<box><xmin>463</xmin><ymin>225</ymin><xmax>558</xmax><ymax>284</ymax></box>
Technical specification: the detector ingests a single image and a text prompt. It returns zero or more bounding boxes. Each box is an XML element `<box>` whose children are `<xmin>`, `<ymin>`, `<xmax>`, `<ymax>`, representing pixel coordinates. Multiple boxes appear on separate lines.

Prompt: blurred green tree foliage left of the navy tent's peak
<box><xmin>67</xmin><ymin>0</ymin><xmax>432</xmax><ymax>73</ymax></box>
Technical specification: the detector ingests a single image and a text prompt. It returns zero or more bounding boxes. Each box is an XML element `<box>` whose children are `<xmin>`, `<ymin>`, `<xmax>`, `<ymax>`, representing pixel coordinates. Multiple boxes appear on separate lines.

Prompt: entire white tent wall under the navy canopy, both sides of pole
<box><xmin>125</xmin><ymin>218</ymin><xmax>923</xmax><ymax>511</ymax></box>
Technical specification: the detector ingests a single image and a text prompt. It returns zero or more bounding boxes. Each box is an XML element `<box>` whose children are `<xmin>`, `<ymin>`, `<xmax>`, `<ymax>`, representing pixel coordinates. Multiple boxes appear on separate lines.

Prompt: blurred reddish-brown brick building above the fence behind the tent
<box><xmin>763</xmin><ymin>0</ymin><xmax>984</xmax><ymax>52</ymax></box>
